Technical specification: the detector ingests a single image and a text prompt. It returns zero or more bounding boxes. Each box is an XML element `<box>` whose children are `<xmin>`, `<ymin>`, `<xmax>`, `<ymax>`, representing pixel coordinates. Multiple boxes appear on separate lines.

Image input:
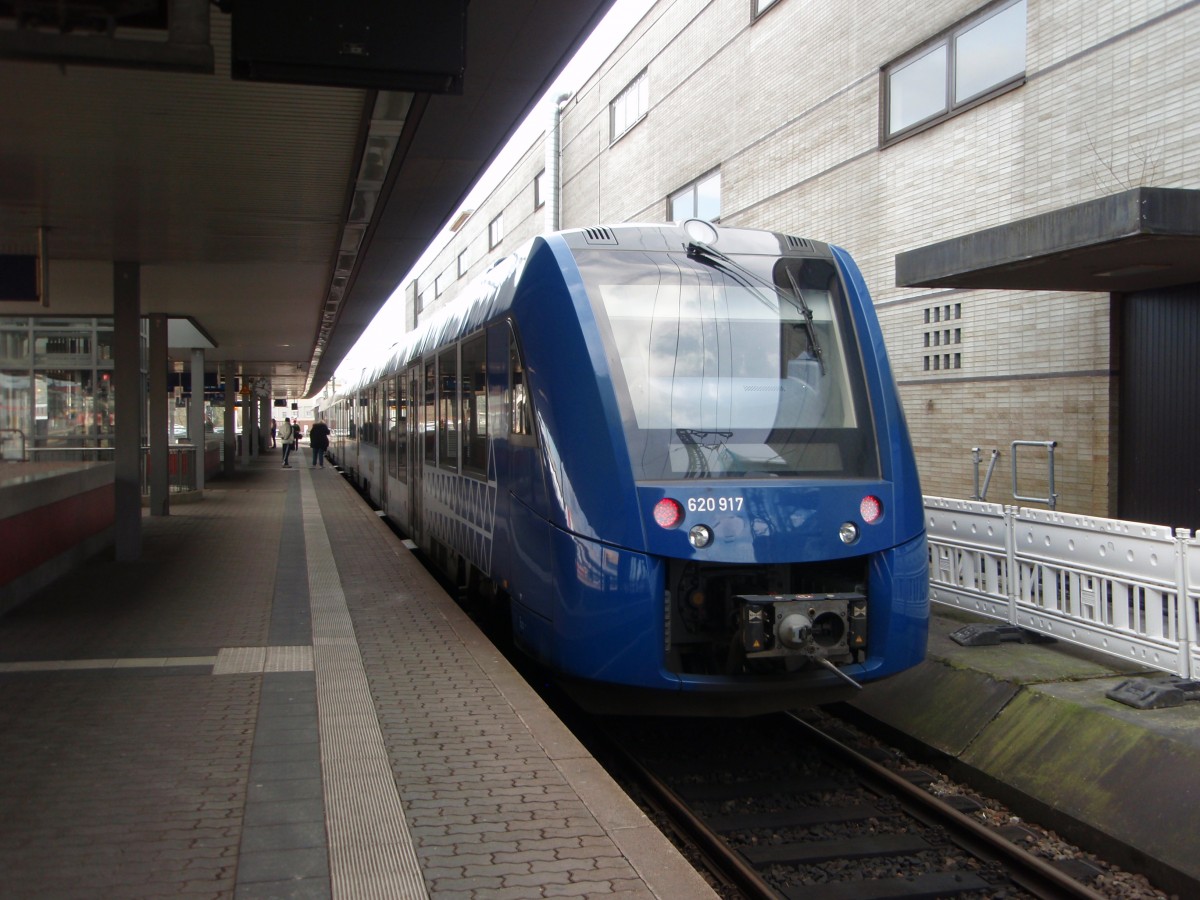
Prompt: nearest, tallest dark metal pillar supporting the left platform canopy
<box><xmin>113</xmin><ymin>263</ymin><xmax>145</xmax><ymax>563</ymax></box>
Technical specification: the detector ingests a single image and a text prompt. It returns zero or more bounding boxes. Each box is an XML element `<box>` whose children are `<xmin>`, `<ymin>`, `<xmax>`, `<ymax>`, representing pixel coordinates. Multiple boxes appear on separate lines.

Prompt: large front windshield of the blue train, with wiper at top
<box><xmin>576</xmin><ymin>252</ymin><xmax>880</xmax><ymax>481</ymax></box>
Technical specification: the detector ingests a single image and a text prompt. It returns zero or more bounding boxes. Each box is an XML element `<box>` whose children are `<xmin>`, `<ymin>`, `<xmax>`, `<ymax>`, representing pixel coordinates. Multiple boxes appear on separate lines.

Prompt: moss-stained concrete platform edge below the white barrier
<box><xmin>851</xmin><ymin>604</ymin><xmax>1200</xmax><ymax>896</ymax></box>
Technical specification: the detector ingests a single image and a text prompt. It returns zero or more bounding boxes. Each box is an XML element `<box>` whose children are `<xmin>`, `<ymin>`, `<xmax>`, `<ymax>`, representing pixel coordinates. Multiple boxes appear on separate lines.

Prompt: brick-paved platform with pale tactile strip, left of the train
<box><xmin>0</xmin><ymin>455</ymin><xmax>713</xmax><ymax>900</ymax></box>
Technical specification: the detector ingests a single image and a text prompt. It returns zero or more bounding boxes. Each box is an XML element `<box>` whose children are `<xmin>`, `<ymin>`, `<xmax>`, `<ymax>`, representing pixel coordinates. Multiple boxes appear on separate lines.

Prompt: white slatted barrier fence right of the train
<box><xmin>925</xmin><ymin>497</ymin><xmax>1200</xmax><ymax>678</ymax></box>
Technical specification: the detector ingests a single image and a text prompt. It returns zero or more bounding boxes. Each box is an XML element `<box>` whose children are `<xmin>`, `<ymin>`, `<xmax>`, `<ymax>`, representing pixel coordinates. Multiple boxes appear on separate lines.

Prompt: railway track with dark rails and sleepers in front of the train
<box><xmin>595</xmin><ymin>715</ymin><xmax>1103</xmax><ymax>900</ymax></box>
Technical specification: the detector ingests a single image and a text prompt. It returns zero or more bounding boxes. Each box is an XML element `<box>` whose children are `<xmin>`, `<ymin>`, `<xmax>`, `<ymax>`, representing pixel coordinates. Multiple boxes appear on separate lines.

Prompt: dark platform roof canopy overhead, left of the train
<box><xmin>0</xmin><ymin>0</ymin><xmax>613</xmax><ymax>397</ymax></box>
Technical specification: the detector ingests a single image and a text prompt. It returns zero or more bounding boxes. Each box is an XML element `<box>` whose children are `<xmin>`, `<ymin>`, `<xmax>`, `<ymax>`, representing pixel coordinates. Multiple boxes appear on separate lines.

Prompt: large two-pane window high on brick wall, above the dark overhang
<box><xmin>883</xmin><ymin>0</ymin><xmax>1026</xmax><ymax>142</ymax></box>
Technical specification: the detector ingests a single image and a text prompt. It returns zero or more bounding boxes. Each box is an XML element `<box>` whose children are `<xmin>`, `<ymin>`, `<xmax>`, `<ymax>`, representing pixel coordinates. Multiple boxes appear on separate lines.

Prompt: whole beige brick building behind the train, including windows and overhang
<box><xmin>408</xmin><ymin>0</ymin><xmax>1200</xmax><ymax>528</ymax></box>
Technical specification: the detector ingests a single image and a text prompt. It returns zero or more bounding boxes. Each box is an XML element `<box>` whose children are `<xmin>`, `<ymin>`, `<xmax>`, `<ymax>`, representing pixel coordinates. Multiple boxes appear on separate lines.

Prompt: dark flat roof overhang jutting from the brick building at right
<box><xmin>896</xmin><ymin>187</ymin><xmax>1200</xmax><ymax>293</ymax></box>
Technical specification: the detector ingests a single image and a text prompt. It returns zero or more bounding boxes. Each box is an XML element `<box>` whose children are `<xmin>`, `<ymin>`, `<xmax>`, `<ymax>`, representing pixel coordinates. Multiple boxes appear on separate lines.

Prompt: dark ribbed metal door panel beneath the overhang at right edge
<box><xmin>1117</xmin><ymin>284</ymin><xmax>1200</xmax><ymax>529</ymax></box>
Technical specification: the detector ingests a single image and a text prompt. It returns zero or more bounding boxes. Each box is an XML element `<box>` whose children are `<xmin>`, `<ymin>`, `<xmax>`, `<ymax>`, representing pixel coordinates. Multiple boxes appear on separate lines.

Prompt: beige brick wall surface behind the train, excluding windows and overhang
<box><xmin>408</xmin><ymin>0</ymin><xmax>1200</xmax><ymax>515</ymax></box>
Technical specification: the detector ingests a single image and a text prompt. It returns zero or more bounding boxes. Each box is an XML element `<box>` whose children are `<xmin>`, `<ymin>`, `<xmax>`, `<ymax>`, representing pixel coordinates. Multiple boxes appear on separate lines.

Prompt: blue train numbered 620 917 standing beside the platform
<box><xmin>326</xmin><ymin>220</ymin><xmax>929</xmax><ymax>715</ymax></box>
